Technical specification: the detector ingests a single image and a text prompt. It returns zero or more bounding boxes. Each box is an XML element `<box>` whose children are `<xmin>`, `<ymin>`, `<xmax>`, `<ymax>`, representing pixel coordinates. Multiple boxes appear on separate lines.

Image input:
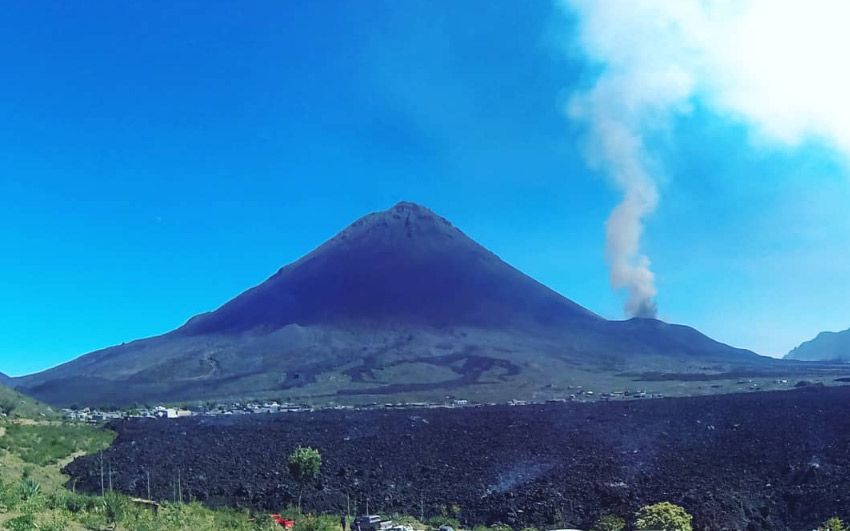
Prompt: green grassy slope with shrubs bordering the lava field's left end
<box><xmin>0</xmin><ymin>414</ymin><xmax>284</xmax><ymax>531</ymax></box>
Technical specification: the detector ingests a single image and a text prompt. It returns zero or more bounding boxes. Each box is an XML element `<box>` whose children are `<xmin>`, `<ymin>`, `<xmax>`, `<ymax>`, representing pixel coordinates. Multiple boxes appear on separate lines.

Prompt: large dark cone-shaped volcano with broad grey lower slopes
<box><xmin>15</xmin><ymin>202</ymin><xmax>765</xmax><ymax>404</ymax></box>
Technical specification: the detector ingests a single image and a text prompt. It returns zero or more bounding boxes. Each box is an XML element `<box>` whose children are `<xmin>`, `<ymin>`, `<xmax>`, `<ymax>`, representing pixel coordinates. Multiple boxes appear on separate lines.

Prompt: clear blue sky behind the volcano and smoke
<box><xmin>0</xmin><ymin>1</ymin><xmax>850</xmax><ymax>375</ymax></box>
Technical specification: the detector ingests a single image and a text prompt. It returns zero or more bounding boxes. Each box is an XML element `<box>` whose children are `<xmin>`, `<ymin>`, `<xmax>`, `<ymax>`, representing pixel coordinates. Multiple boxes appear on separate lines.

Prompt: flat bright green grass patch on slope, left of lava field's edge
<box><xmin>0</xmin><ymin>423</ymin><xmax>115</xmax><ymax>466</ymax></box>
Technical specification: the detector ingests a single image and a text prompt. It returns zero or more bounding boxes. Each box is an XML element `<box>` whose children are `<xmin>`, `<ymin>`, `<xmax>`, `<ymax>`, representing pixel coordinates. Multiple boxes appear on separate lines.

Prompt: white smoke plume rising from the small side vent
<box><xmin>560</xmin><ymin>0</ymin><xmax>850</xmax><ymax>317</ymax></box>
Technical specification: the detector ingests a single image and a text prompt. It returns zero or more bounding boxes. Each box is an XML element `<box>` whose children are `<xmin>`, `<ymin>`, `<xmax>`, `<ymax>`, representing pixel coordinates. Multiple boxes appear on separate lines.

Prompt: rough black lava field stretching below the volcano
<box><xmin>67</xmin><ymin>387</ymin><xmax>850</xmax><ymax>530</ymax></box>
